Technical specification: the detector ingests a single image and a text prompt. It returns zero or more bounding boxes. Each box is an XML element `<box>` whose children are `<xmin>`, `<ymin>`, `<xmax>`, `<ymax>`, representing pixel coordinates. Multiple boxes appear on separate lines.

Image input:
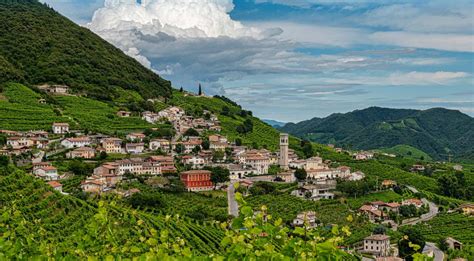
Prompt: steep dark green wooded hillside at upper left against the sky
<box><xmin>0</xmin><ymin>0</ymin><xmax>171</xmax><ymax>100</ymax></box>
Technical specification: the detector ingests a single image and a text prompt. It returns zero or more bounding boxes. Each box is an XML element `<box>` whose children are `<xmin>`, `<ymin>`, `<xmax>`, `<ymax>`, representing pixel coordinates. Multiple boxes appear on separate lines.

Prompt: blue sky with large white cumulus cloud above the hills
<box><xmin>42</xmin><ymin>0</ymin><xmax>474</xmax><ymax>122</ymax></box>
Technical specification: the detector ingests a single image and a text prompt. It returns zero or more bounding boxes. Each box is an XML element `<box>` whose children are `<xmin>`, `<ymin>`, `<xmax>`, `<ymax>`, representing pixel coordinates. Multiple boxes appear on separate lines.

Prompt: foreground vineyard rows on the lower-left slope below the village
<box><xmin>0</xmin><ymin>167</ymin><xmax>223</xmax><ymax>259</ymax></box>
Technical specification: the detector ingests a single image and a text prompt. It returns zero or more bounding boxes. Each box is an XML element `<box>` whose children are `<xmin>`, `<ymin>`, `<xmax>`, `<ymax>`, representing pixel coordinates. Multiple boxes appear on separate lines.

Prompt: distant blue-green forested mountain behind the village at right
<box><xmin>280</xmin><ymin>107</ymin><xmax>474</xmax><ymax>159</ymax></box>
